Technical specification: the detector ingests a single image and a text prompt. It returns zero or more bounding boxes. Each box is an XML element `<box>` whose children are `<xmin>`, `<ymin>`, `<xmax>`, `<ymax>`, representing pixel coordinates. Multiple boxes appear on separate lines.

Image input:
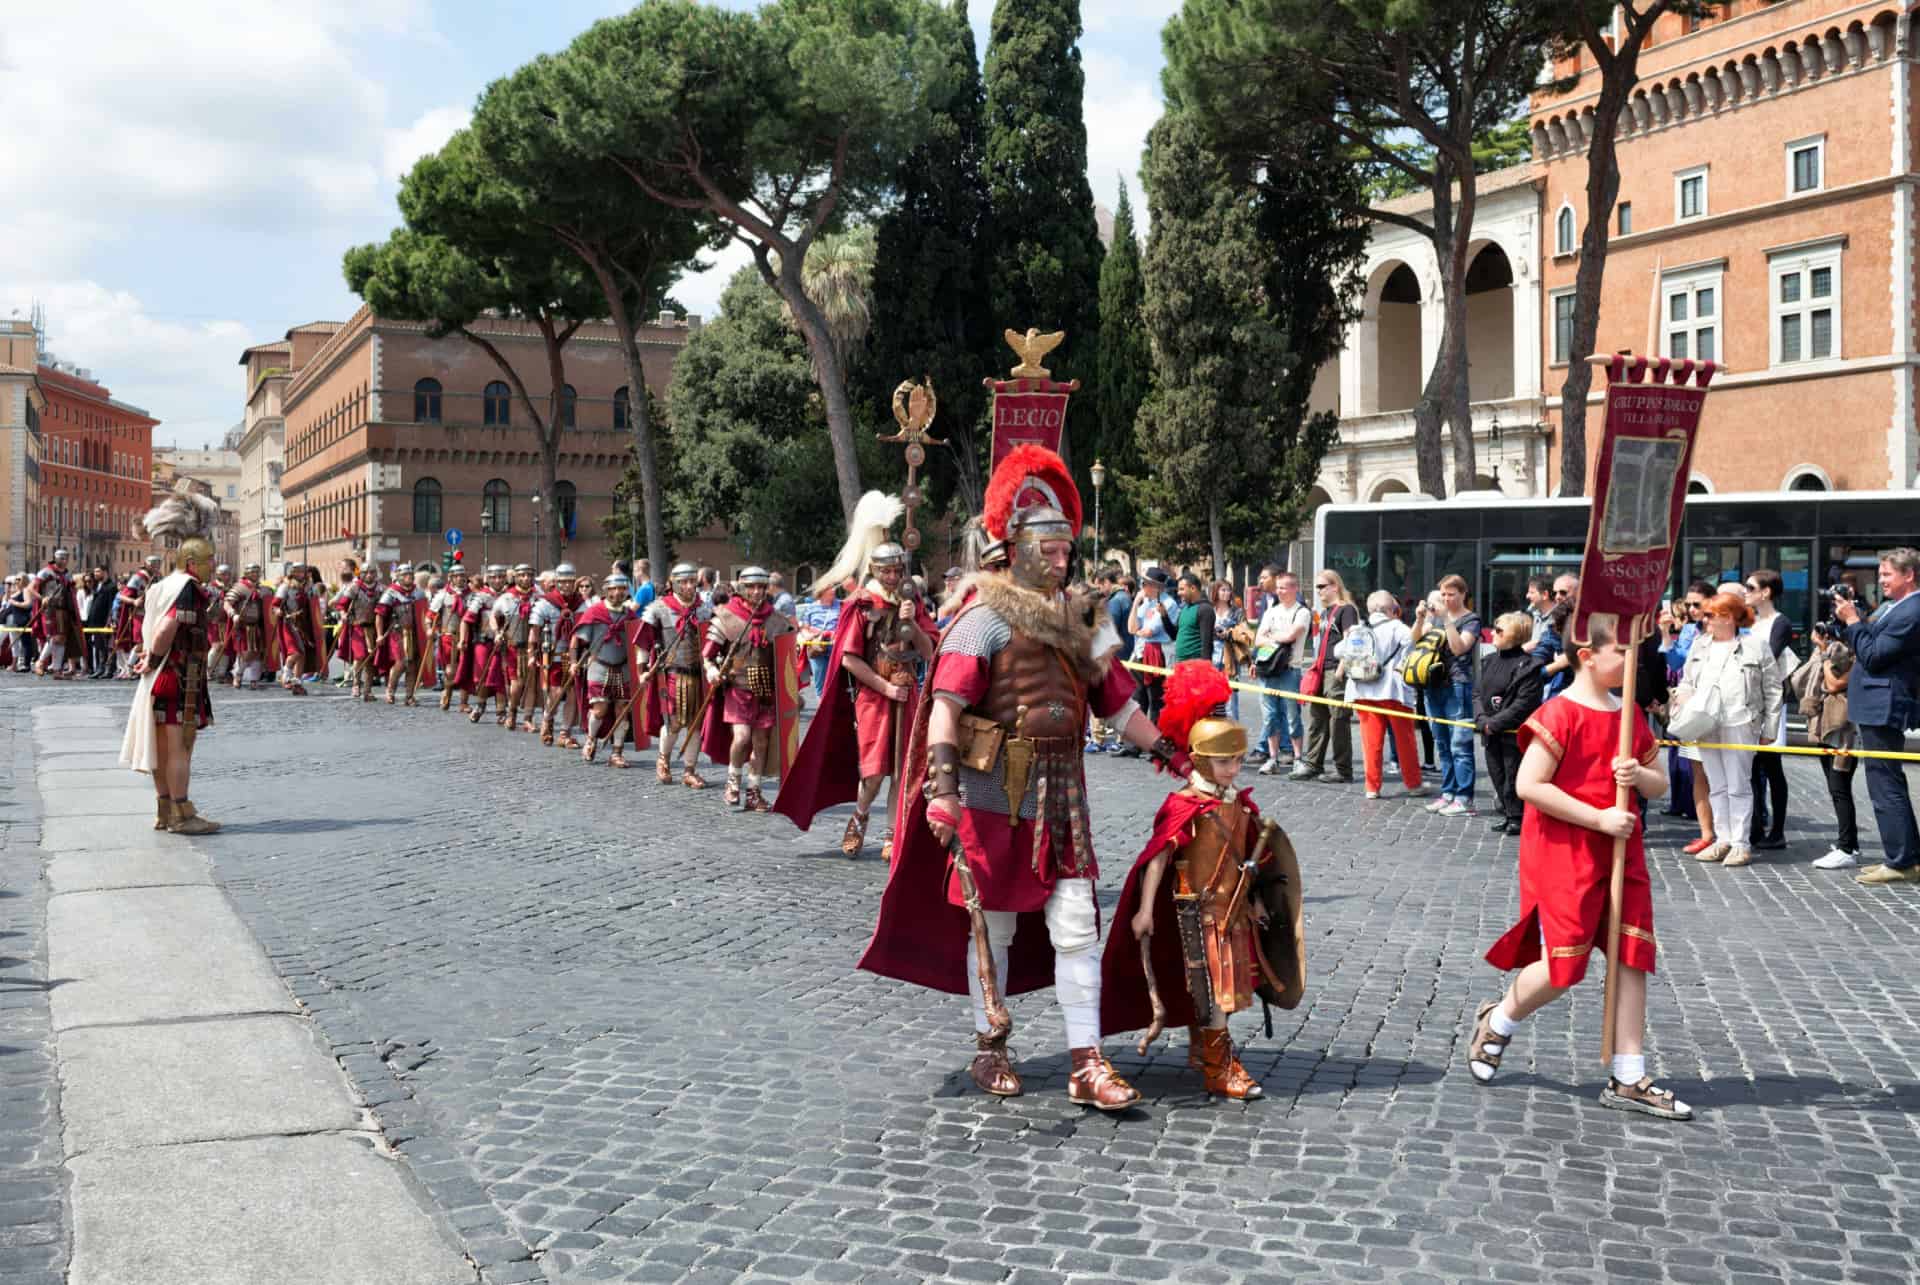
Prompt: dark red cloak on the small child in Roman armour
<box><xmin>1100</xmin><ymin>789</ymin><xmax>1260</xmax><ymax>1035</ymax></box>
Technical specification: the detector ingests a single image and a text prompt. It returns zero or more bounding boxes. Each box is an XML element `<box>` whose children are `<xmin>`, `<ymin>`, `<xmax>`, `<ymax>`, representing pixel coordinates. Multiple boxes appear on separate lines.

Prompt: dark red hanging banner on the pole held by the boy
<box><xmin>1572</xmin><ymin>357</ymin><xmax>1715</xmax><ymax>643</ymax></box>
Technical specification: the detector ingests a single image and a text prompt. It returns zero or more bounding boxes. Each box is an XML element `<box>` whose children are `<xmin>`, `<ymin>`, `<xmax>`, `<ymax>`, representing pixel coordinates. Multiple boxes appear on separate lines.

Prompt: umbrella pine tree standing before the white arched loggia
<box><xmin>1164</xmin><ymin>0</ymin><xmax>1557</xmax><ymax>496</ymax></box>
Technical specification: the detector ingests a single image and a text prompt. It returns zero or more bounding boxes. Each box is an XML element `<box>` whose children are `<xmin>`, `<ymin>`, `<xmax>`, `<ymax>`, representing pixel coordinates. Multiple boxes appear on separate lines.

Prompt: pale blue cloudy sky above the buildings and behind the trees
<box><xmin>0</xmin><ymin>0</ymin><xmax>1179</xmax><ymax>446</ymax></box>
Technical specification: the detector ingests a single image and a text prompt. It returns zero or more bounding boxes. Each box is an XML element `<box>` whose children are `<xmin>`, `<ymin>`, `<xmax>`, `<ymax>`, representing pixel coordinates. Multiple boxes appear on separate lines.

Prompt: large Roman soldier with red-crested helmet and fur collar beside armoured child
<box><xmin>860</xmin><ymin>444</ymin><xmax>1192</xmax><ymax>1110</ymax></box>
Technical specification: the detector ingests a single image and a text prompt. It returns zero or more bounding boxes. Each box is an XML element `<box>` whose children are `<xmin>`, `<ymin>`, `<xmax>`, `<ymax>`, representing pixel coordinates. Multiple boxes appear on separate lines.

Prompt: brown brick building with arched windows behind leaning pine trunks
<box><xmin>280</xmin><ymin>307</ymin><xmax>702</xmax><ymax>574</ymax></box>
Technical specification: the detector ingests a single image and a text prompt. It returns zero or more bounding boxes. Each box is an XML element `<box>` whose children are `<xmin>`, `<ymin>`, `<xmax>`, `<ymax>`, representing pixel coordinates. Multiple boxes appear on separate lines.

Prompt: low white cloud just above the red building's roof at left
<box><xmin>19</xmin><ymin>280</ymin><xmax>251</xmax><ymax>446</ymax></box>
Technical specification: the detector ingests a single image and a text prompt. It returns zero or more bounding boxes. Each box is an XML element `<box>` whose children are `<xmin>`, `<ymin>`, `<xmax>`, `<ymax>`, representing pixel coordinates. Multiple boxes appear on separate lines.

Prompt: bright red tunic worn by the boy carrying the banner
<box><xmin>1486</xmin><ymin>695</ymin><xmax>1659</xmax><ymax>987</ymax></box>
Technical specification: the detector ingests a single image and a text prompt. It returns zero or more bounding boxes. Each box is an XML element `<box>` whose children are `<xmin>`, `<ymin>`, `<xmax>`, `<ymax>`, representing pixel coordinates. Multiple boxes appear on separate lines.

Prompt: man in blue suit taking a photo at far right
<box><xmin>1834</xmin><ymin>547</ymin><xmax>1920</xmax><ymax>884</ymax></box>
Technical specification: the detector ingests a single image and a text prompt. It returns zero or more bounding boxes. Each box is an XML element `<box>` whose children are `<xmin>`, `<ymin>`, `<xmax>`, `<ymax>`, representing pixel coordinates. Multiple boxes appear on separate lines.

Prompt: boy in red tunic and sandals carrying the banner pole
<box><xmin>1467</xmin><ymin>620</ymin><xmax>1693</xmax><ymax>1120</ymax></box>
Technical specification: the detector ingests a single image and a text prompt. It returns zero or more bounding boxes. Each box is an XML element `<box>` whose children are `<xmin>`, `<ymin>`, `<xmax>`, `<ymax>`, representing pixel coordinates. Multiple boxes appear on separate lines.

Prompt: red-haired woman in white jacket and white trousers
<box><xmin>1674</xmin><ymin>592</ymin><xmax>1780</xmax><ymax>866</ymax></box>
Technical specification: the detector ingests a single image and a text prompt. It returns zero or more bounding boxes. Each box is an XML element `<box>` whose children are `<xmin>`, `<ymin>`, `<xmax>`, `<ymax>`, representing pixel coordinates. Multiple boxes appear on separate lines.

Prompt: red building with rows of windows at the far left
<box><xmin>36</xmin><ymin>361</ymin><xmax>159</xmax><ymax>574</ymax></box>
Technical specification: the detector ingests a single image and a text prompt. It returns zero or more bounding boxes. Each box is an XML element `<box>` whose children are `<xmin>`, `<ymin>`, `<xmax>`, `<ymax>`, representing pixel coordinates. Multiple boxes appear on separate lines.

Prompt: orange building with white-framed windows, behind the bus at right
<box><xmin>1532</xmin><ymin>0</ymin><xmax>1920</xmax><ymax>492</ymax></box>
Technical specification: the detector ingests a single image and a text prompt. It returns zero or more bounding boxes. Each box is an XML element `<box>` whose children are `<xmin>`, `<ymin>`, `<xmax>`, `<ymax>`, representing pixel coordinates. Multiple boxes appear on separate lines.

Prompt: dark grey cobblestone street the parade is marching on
<box><xmin>0</xmin><ymin>676</ymin><xmax>1920</xmax><ymax>1285</ymax></box>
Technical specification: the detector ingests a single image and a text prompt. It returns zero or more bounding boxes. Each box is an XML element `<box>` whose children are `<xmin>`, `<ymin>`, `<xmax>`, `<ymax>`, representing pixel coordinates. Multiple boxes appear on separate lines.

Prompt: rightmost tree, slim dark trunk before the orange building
<box><xmin>1546</xmin><ymin>0</ymin><xmax>1716</xmax><ymax>496</ymax></box>
